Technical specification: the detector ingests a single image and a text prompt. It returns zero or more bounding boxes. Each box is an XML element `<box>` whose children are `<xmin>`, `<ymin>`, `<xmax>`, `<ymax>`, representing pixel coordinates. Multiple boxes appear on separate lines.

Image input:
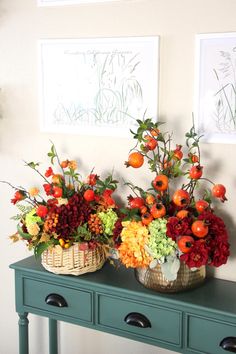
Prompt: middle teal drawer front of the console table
<box><xmin>98</xmin><ymin>294</ymin><xmax>182</xmax><ymax>346</ymax></box>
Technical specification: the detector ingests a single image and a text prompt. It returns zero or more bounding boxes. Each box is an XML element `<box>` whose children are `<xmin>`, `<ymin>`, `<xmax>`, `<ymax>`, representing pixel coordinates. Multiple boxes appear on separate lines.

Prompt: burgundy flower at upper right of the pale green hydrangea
<box><xmin>166</xmin><ymin>216</ymin><xmax>192</xmax><ymax>241</ymax></box>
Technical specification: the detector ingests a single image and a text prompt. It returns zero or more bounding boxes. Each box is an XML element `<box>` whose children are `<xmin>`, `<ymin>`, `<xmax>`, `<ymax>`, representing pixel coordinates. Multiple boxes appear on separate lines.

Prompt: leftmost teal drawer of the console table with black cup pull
<box><xmin>23</xmin><ymin>278</ymin><xmax>93</xmax><ymax>322</ymax></box>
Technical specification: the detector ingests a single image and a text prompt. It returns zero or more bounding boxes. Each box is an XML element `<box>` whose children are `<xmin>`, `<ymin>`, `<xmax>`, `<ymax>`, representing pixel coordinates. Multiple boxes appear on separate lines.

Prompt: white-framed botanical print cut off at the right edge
<box><xmin>194</xmin><ymin>32</ymin><xmax>236</xmax><ymax>144</ymax></box>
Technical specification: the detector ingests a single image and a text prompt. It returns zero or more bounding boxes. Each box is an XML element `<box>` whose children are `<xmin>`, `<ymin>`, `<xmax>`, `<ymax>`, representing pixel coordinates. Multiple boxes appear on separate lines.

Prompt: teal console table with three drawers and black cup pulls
<box><xmin>11</xmin><ymin>257</ymin><xmax>236</xmax><ymax>354</ymax></box>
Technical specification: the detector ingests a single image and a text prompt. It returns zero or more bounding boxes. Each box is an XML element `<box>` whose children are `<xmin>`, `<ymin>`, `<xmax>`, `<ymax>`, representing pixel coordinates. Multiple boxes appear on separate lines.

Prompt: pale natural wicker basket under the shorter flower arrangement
<box><xmin>41</xmin><ymin>243</ymin><xmax>106</xmax><ymax>275</ymax></box>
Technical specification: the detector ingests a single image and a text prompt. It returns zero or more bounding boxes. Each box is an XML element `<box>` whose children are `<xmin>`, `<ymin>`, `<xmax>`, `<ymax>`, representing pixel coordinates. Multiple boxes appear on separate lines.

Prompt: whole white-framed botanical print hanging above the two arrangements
<box><xmin>39</xmin><ymin>36</ymin><xmax>159</xmax><ymax>137</ymax></box>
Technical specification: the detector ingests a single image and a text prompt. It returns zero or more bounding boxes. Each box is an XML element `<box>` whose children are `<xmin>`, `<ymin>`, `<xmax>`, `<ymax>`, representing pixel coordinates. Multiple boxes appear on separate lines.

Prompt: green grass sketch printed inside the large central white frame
<box><xmin>54</xmin><ymin>51</ymin><xmax>144</xmax><ymax>127</ymax></box>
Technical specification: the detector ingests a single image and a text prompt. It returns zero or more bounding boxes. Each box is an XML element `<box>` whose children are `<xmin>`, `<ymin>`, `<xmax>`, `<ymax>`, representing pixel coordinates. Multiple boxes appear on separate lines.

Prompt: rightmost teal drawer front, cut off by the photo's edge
<box><xmin>186</xmin><ymin>314</ymin><xmax>236</xmax><ymax>354</ymax></box>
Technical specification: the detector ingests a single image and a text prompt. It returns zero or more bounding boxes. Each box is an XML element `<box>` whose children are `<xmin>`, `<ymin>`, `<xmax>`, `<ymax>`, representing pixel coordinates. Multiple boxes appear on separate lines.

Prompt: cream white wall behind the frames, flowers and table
<box><xmin>0</xmin><ymin>0</ymin><xmax>236</xmax><ymax>354</ymax></box>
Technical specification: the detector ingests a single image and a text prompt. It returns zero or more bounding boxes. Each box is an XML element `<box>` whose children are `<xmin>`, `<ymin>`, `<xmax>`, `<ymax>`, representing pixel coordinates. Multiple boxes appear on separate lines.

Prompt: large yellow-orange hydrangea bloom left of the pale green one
<box><xmin>118</xmin><ymin>221</ymin><xmax>152</xmax><ymax>268</ymax></box>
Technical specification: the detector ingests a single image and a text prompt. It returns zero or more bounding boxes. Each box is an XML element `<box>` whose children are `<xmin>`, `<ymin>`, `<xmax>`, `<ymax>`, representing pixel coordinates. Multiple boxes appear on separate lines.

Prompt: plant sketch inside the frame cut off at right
<box><xmin>213</xmin><ymin>46</ymin><xmax>236</xmax><ymax>133</ymax></box>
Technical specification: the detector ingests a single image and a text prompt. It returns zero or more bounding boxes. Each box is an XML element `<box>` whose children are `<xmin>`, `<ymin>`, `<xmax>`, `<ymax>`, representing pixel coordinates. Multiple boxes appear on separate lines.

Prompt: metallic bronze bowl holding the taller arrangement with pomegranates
<box><xmin>135</xmin><ymin>262</ymin><xmax>206</xmax><ymax>293</ymax></box>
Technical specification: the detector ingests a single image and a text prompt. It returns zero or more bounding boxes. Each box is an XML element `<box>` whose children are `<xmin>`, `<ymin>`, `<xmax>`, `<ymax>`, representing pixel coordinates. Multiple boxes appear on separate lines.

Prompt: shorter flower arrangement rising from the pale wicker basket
<box><xmin>4</xmin><ymin>144</ymin><xmax>119</xmax><ymax>256</ymax></box>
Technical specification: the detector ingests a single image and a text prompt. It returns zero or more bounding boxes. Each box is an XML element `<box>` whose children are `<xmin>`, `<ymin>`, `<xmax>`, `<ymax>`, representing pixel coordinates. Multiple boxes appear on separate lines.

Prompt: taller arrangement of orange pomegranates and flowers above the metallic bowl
<box><xmin>118</xmin><ymin>119</ymin><xmax>229</xmax><ymax>280</ymax></box>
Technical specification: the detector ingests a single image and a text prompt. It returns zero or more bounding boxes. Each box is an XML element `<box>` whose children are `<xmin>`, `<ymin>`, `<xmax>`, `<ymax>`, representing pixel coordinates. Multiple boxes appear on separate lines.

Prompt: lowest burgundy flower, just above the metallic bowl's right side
<box><xmin>180</xmin><ymin>240</ymin><xmax>210</xmax><ymax>268</ymax></box>
